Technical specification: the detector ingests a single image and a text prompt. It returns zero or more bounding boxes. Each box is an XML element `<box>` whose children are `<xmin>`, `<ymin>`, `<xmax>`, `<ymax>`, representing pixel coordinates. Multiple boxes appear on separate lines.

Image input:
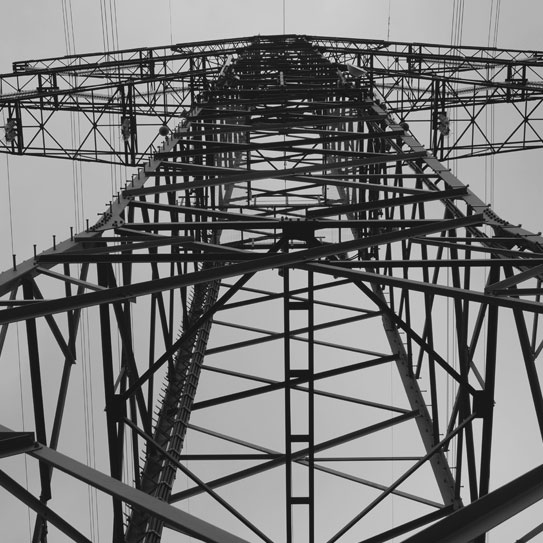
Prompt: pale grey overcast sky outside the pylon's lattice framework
<box><xmin>0</xmin><ymin>0</ymin><xmax>543</xmax><ymax>542</ymax></box>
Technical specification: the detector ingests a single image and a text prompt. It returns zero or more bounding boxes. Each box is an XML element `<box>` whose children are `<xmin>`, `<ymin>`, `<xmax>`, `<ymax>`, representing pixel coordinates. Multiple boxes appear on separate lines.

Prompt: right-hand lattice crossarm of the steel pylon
<box><xmin>309</xmin><ymin>37</ymin><xmax>543</xmax><ymax>160</ymax></box>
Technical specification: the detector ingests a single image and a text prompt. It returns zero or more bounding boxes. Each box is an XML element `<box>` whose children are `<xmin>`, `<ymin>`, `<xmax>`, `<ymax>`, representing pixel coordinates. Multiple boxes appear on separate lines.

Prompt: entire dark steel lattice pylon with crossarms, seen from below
<box><xmin>0</xmin><ymin>36</ymin><xmax>543</xmax><ymax>543</ymax></box>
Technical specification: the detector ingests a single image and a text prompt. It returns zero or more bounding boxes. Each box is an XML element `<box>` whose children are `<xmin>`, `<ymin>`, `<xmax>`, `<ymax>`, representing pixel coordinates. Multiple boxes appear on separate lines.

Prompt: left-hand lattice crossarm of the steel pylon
<box><xmin>0</xmin><ymin>38</ymin><xmax>249</xmax><ymax>166</ymax></box>
